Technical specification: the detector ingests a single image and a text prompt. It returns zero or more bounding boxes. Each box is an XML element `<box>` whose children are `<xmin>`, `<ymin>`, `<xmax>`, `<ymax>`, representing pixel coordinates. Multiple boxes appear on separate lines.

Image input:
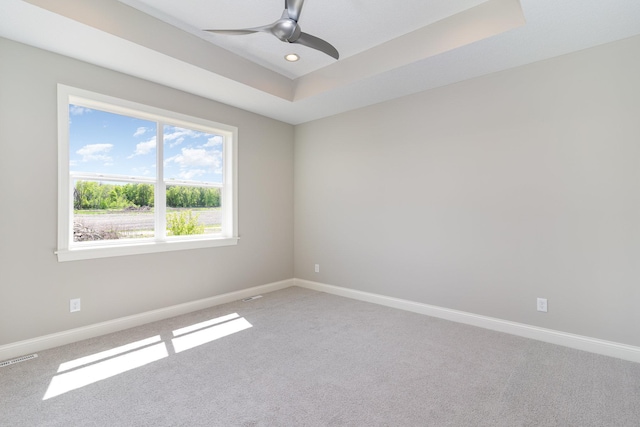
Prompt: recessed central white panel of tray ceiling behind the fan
<box><xmin>120</xmin><ymin>0</ymin><xmax>486</xmax><ymax>79</ymax></box>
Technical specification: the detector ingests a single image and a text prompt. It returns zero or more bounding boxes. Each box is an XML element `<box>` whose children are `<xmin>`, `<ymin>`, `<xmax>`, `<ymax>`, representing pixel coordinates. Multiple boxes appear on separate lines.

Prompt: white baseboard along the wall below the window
<box><xmin>0</xmin><ymin>279</ymin><xmax>293</xmax><ymax>361</ymax></box>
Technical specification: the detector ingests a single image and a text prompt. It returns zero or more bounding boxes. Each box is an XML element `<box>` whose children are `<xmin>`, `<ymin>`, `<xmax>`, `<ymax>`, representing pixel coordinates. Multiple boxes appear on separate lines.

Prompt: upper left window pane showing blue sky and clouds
<box><xmin>69</xmin><ymin>104</ymin><xmax>156</xmax><ymax>178</ymax></box>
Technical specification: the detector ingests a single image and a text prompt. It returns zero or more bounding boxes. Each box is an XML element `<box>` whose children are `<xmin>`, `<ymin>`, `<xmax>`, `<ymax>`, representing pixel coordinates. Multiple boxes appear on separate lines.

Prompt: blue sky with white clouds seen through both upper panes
<box><xmin>69</xmin><ymin>104</ymin><xmax>222</xmax><ymax>183</ymax></box>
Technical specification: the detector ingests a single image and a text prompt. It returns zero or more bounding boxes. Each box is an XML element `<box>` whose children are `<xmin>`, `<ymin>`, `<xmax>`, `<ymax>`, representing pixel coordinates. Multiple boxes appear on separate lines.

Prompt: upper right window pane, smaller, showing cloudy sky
<box><xmin>163</xmin><ymin>125</ymin><xmax>223</xmax><ymax>184</ymax></box>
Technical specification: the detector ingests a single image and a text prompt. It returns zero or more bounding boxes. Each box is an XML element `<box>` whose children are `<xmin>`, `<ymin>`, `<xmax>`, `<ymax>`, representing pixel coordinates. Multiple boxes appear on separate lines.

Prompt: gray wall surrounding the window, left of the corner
<box><xmin>0</xmin><ymin>39</ymin><xmax>294</xmax><ymax>345</ymax></box>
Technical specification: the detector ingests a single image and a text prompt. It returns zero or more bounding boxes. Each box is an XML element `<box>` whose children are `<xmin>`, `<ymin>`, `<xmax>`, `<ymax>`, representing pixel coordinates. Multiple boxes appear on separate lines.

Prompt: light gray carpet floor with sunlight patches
<box><xmin>0</xmin><ymin>287</ymin><xmax>640</xmax><ymax>427</ymax></box>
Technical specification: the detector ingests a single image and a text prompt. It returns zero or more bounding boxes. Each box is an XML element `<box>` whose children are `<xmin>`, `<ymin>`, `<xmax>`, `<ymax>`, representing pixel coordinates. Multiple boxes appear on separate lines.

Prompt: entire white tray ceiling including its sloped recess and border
<box><xmin>0</xmin><ymin>0</ymin><xmax>640</xmax><ymax>124</ymax></box>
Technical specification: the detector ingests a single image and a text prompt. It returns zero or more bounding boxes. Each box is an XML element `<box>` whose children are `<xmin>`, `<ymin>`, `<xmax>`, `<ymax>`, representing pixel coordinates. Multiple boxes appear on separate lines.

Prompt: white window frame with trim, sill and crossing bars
<box><xmin>55</xmin><ymin>84</ymin><xmax>239</xmax><ymax>262</ymax></box>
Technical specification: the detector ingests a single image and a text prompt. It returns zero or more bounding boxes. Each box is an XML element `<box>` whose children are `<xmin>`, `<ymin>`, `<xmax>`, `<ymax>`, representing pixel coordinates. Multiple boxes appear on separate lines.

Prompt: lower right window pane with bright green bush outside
<box><xmin>166</xmin><ymin>185</ymin><xmax>222</xmax><ymax>236</ymax></box>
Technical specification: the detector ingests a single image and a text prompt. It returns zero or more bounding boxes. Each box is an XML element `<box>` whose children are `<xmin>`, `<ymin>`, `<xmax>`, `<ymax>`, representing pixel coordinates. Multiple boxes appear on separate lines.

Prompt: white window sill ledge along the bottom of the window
<box><xmin>55</xmin><ymin>237</ymin><xmax>239</xmax><ymax>262</ymax></box>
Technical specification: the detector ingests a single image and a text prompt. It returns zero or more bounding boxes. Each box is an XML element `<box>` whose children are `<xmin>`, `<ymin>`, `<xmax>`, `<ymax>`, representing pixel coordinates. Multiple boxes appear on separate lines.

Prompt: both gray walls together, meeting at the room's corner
<box><xmin>0</xmin><ymin>33</ymin><xmax>640</xmax><ymax>352</ymax></box>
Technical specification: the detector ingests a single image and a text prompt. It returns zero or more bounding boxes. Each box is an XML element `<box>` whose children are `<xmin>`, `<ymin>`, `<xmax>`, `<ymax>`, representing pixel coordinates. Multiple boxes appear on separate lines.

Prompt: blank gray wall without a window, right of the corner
<box><xmin>294</xmin><ymin>37</ymin><xmax>640</xmax><ymax>346</ymax></box>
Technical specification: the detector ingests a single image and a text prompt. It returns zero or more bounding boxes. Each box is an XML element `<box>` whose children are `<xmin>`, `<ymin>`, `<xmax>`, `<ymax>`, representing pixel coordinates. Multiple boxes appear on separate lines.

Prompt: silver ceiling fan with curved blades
<box><xmin>204</xmin><ymin>0</ymin><xmax>340</xmax><ymax>59</ymax></box>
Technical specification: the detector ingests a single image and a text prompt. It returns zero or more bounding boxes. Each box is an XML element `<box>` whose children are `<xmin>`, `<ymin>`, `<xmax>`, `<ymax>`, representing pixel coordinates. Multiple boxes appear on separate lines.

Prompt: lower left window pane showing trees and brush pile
<box><xmin>73</xmin><ymin>180</ymin><xmax>154</xmax><ymax>242</ymax></box>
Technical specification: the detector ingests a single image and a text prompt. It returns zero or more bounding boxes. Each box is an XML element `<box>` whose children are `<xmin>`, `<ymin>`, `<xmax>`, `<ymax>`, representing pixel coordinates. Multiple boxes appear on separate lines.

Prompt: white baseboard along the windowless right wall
<box><xmin>293</xmin><ymin>279</ymin><xmax>640</xmax><ymax>363</ymax></box>
